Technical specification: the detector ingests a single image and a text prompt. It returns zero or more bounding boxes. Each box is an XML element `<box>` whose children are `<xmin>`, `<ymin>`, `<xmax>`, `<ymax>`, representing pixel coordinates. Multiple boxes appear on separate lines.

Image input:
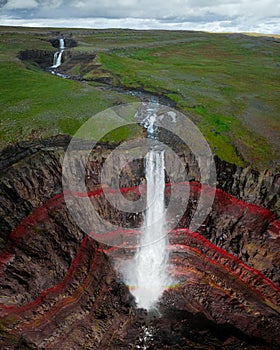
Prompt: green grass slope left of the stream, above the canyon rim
<box><xmin>0</xmin><ymin>62</ymin><xmax>137</xmax><ymax>146</ymax></box>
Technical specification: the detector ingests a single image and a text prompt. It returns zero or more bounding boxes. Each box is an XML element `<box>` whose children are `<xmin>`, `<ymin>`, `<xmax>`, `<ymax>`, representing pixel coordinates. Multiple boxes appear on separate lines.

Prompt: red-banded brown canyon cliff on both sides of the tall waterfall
<box><xmin>0</xmin><ymin>138</ymin><xmax>280</xmax><ymax>349</ymax></box>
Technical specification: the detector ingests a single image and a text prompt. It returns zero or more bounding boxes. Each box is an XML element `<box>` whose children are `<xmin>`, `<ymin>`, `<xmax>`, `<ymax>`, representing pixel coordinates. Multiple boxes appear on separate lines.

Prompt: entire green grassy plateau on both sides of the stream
<box><xmin>0</xmin><ymin>27</ymin><xmax>280</xmax><ymax>169</ymax></box>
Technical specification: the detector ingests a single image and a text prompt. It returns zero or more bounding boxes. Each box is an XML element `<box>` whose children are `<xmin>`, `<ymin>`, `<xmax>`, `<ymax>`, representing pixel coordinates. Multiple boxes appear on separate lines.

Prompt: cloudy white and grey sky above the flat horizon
<box><xmin>0</xmin><ymin>0</ymin><xmax>280</xmax><ymax>34</ymax></box>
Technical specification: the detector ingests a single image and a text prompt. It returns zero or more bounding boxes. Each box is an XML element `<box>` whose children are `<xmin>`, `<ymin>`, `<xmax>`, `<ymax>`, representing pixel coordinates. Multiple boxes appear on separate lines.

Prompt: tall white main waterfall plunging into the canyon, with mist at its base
<box><xmin>121</xmin><ymin>108</ymin><xmax>174</xmax><ymax>311</ymax></box>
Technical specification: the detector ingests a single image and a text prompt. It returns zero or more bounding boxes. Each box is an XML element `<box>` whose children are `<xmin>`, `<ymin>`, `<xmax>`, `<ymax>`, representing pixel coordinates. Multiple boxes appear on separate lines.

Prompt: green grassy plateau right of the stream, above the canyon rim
<box><xmin>95</xmin><ymin>34</ymin><xmax>280</xmax><ymax>168</ymax></box>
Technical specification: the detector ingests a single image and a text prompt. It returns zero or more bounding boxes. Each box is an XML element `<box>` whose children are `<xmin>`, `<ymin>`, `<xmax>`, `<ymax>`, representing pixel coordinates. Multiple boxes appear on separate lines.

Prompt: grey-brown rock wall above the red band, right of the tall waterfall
<box><xmin>160</xmin><ymin>130</ymin><xmax>280</xmax><ymax>218</ymax></box>
